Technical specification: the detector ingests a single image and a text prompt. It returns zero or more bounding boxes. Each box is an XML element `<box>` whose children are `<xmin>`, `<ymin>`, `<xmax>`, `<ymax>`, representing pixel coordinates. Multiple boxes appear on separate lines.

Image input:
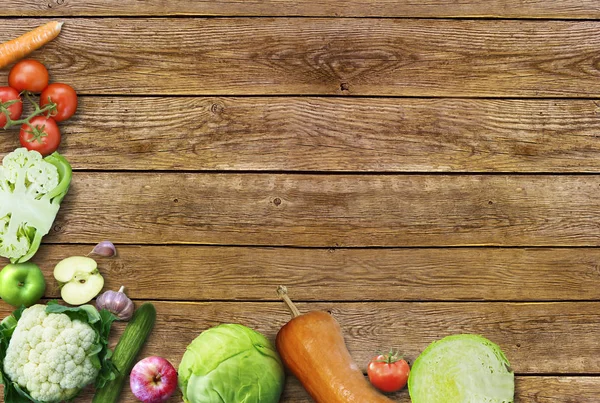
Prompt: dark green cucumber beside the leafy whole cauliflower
<box><xmin>92</xmin><ymin>302</ymin><xmax>156</xmax><ymax>403</ymax></box>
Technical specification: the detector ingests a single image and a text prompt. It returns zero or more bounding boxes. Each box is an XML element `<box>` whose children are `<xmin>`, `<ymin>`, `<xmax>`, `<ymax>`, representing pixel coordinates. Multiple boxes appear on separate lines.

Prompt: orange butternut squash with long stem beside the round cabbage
<box><xmin>276</xmin><ymin>286</ymin><xmax>393</xmax><ymax>403</ymax></box>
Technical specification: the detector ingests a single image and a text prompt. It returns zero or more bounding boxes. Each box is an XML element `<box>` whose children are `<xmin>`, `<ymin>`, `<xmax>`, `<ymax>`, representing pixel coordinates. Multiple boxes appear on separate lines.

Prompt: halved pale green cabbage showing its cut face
<box><xmin>408</xmin><ymin>334</ymin><xmax>515</xmax><ymax>403</ymax></box>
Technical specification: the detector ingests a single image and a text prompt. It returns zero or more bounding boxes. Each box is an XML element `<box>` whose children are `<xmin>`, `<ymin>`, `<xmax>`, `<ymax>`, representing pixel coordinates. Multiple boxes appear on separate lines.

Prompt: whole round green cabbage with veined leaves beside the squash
<box><xmin>178</xmin><ymin>324</ymin><xmax>285</xmax><ymax>403</ymax></box>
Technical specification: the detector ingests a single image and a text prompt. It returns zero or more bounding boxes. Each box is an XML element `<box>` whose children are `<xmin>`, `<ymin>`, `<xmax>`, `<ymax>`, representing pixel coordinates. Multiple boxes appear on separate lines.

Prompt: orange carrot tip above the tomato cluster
<box><xmin>0</xmin><ymin>21</ymin><xmax>63</xmax><ymax>69</ymax></box>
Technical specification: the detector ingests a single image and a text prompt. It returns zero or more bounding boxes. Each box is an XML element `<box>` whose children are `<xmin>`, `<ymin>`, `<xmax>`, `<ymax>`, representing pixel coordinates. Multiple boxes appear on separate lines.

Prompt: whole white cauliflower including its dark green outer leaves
<box><xmin>0</xmin><ymin>303</ymin><xmax>114</xmax><ymax>403</ymax></box>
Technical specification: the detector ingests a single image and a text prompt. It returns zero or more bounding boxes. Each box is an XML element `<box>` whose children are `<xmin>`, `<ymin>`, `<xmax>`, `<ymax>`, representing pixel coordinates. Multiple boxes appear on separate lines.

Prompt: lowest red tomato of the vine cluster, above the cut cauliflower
<box><xmin>19</xmin><ymin>116</ymin><xmax>60</xmax><ymax>157</ymax></box>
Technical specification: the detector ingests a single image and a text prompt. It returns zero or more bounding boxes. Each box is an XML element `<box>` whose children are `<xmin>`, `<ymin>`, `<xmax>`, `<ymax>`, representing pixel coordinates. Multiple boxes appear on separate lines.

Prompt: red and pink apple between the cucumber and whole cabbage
<box><xmin>129</xmin><ymin>357</ymin><xmax>177</xmax><ymax>403</ymax></box>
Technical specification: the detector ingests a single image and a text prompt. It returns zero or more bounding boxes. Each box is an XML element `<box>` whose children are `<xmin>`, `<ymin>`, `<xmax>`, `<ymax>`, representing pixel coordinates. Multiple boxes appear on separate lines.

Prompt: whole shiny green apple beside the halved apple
<box><xmin>0</xmin><ymin>262</ymin><xmax>46</xmax><ymax>307</ymax></box>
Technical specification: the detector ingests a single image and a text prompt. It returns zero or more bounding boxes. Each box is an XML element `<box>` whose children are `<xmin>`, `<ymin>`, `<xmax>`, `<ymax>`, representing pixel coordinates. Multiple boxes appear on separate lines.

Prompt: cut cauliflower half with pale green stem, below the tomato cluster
<box><xmin>0</xmin><ymin>148</ymin><xmax>71</xmax><ymax>263</ymax></box>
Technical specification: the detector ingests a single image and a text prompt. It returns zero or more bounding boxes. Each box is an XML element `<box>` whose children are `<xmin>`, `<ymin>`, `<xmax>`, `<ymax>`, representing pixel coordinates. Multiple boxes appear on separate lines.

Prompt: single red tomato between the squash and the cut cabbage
<box><xmin>367</xmin><ymin>353</ymin><xmax>410</xmax><ymax>392</ymax></box>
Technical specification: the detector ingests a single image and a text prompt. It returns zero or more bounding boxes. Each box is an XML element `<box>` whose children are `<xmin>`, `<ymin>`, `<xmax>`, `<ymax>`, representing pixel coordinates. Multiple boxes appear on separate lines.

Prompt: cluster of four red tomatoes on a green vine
<box><xmin>0</xmin><ymin>59</ymin><xmax>77</xmax><ymax>156</ymax></box>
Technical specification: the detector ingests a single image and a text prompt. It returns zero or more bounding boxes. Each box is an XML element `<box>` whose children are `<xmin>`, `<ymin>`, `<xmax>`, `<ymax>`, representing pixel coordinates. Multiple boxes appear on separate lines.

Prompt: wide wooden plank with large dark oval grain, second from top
<box><xmin>0</xmin><ymin>18</ymin><xmax>600</xmax><ymax>98</ymax></box>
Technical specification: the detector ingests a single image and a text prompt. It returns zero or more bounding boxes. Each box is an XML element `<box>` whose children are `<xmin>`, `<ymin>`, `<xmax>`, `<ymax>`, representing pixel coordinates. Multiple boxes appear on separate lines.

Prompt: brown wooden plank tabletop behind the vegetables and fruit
<box><xmin>0</xmin><ymin>0</ymin><xmax>600</xmax><ymax>403</ymax></box>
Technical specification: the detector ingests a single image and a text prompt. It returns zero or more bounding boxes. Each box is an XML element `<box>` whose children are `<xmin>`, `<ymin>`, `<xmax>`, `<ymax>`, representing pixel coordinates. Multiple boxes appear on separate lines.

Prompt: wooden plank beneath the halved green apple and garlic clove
<box><xmin>25</xmin><ymin>245</ymin><xmax>600</xmax><ymax>301</ymax></box>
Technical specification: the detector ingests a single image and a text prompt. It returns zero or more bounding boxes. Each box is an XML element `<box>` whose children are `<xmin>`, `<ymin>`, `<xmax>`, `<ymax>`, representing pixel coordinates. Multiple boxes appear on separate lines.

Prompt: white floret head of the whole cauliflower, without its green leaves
<box><xmin>4</xmin><ymin>304</ymin><xmax>100</xmax><ymax>402</ymax></box>
